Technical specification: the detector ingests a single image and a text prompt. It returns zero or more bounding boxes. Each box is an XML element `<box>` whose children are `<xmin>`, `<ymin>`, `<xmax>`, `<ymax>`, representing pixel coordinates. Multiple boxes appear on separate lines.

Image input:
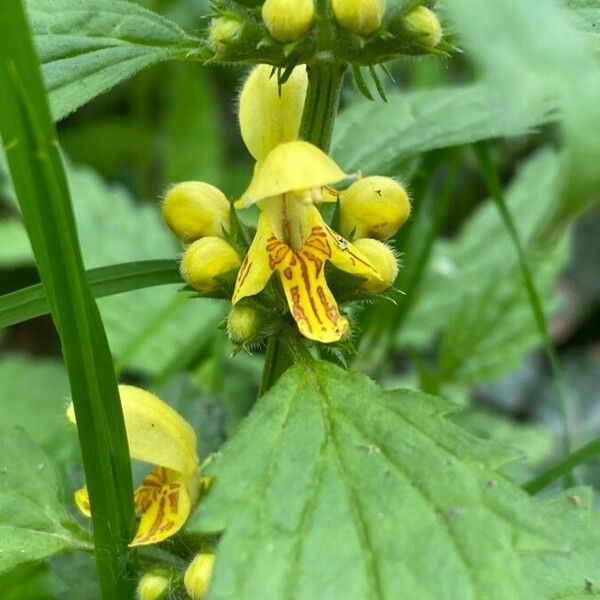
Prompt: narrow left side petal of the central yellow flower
<box><xmin>231</xmin><ymin>211</ymin><xmax>274</xmax><ymax>304</ymax></box>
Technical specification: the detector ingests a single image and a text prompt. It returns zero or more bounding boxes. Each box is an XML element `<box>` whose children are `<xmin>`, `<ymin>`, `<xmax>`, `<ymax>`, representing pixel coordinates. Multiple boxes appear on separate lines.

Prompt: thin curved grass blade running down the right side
<box><xmin>473</xmin><ymin>142</ymin><xmax>574</xmax><ymax>487</ymax></box>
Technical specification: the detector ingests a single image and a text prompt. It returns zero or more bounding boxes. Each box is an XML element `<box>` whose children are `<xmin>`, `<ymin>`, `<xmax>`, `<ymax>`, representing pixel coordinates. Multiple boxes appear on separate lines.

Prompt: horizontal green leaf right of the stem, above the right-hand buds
<box><xmin>332</xmin><ymin>84</ymin><xmax>551</xmax><ymax>175</ymax></box>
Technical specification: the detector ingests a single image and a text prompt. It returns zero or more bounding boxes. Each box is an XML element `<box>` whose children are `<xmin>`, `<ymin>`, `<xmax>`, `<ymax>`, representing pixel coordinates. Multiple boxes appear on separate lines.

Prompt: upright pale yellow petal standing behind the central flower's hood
<box><xmin>239</xmin><ymin>65</ymin><xmax>308</xmax><ymax>161</ymax></box>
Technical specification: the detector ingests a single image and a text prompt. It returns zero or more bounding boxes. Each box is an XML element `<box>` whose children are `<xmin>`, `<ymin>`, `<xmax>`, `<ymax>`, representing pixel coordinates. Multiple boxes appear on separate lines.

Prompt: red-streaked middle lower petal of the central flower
<box><xmin>267</xmin><ymin>225</ymin><xmax>348</xmax><ymax>343</ymax></box>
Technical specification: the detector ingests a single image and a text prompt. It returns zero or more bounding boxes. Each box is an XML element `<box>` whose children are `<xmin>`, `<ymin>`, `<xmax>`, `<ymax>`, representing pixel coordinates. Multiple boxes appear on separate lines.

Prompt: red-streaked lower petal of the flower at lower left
<box><xmin>130</xmin><ymin>467</ymin><xmax>192</xmax><ymax>546</ymax></box>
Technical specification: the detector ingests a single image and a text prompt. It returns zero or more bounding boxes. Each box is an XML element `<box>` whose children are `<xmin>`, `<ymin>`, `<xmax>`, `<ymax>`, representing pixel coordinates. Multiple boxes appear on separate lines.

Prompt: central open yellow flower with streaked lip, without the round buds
<box><xmin>231</xmin><ymin>66</ymin><xmax>379</xmax><ymax>343</ymax></box>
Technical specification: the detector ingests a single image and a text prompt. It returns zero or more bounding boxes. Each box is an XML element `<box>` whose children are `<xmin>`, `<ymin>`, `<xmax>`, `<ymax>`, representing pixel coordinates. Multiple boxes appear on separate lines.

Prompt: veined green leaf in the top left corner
<box><xmin>27</xmin><ymin>0</ymin><xmax>203</xmax><ymax>119</ymax></box>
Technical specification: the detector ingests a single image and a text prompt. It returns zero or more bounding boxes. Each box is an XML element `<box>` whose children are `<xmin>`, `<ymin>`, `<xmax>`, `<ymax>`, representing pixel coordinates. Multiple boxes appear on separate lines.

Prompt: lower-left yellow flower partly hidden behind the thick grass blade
<box><xmin>67</xmin><ymin>385</ymin><xmax>201</xmax><ymax>546</ymax></box>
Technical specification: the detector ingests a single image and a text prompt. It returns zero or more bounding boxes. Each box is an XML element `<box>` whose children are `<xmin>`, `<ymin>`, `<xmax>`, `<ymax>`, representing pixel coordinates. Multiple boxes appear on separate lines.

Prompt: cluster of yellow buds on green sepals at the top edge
<box><xmin>207</xmin><ymin>0</ymin><xmax>446</xmax><ymax>69</ymax></box>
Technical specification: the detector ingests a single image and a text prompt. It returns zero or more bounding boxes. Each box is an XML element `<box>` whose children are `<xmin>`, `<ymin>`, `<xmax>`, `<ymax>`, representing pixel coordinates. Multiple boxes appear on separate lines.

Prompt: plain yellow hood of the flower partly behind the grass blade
<box><xmin>67</xmin><ymin>385</ymin><xmax>199</xmax><ymax>476</ymax></box>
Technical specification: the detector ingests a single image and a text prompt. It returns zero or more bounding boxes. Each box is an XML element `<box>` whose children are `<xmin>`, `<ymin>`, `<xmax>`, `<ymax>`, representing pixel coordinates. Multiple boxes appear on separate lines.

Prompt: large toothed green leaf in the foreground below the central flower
<box><xmin>190</xmin><ymin>363</ymin><xmax>600</xmax><ymax>600</ymax></box>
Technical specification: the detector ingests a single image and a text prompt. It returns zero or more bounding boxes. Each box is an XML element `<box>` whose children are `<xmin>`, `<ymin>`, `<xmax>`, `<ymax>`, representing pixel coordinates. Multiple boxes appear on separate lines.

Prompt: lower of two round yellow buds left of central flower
<box><xmin>180</xmin><ymin>237</ymin><xmax>241</xmax><ymax>292</ymax></box>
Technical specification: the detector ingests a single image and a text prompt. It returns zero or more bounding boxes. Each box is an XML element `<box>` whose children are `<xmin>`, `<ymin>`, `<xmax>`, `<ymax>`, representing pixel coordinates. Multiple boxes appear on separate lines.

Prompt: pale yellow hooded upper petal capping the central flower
<box><xmin>236</xmin><ymin>141</ymin><xmax>348</xmax><ymax>208</ymax></box>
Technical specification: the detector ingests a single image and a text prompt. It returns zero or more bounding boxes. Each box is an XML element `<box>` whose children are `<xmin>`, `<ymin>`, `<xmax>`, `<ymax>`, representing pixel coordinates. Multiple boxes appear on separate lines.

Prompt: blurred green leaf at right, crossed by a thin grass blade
<box><xmin>399</xmin><ymin>150</ymin><xmax>560</xmax><ymax>356</ymax></box>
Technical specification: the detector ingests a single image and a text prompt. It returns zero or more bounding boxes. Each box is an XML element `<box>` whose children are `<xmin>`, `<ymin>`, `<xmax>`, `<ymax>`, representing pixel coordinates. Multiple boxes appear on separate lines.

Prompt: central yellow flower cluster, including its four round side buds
<box><xmin>163</xmin><ymin>65</ymin><xmax>410</xmax><ymax>343</ymax></box>
